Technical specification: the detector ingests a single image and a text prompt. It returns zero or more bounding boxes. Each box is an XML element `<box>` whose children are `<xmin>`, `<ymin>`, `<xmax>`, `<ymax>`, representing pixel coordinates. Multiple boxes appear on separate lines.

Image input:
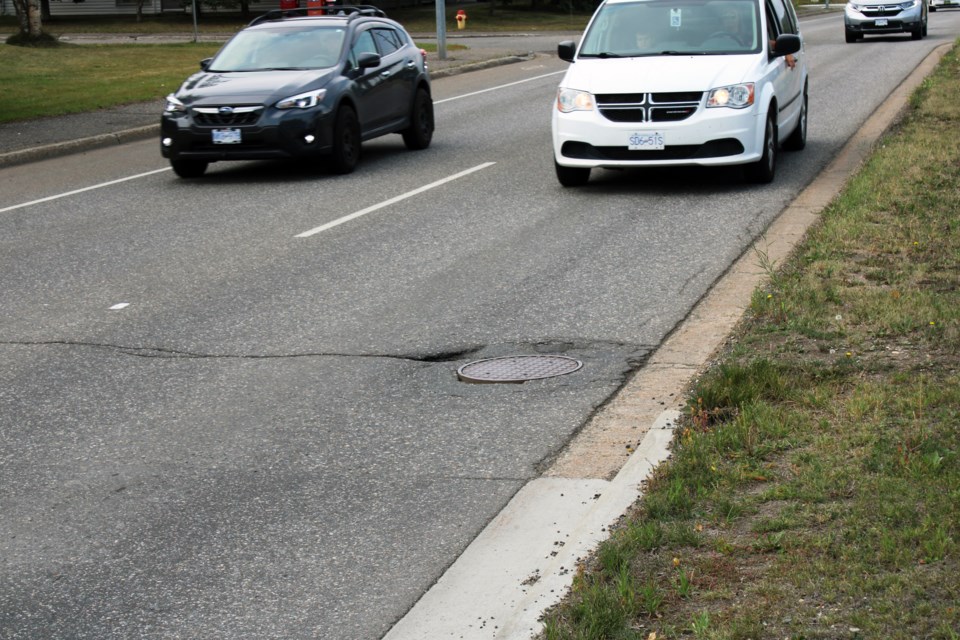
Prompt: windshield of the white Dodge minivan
<box><xmin>579</xmin><ymin>0</ymin><xmax>762</xmax><ymax>58</ymax></box>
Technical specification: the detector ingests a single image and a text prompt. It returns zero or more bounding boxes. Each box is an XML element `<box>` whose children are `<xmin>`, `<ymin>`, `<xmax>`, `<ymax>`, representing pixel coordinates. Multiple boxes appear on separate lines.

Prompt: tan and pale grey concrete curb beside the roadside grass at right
<box><xmin>384</xmin><ymin>44</ymin><xmax>952</xmax><ymax>640</ymax></box>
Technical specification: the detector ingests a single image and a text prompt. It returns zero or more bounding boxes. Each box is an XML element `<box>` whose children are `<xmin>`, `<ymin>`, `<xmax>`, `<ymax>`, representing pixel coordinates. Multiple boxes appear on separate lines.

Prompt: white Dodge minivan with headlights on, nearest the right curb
<box><xmin>552</xmin><ymin>0</ymin><xmax>808</xmax><ymax>186</ymax></box>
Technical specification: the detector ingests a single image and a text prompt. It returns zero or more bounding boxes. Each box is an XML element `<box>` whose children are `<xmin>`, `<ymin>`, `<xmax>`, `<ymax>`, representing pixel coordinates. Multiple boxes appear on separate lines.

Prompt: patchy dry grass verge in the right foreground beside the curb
<box><xmin>541</xmin><ymin>41</ymin><xmax>960</xmax><ymax>640</ymax></box>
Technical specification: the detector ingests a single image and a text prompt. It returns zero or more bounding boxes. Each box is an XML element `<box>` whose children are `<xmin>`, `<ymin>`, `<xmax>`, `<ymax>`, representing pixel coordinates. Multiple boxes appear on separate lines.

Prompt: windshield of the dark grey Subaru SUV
<box><xmin>209</xmin><ymin>26</ymin><xmax>346</xmax><ymax>71</ymax></box>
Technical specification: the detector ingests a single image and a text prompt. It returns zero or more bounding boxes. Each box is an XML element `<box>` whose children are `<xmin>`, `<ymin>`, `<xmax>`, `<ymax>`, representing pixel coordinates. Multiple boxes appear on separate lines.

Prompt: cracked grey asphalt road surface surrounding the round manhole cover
<box><xmin>0</xmin><ymin>12</ymin><xmax>960</xmax><ymax>640</ymax></box>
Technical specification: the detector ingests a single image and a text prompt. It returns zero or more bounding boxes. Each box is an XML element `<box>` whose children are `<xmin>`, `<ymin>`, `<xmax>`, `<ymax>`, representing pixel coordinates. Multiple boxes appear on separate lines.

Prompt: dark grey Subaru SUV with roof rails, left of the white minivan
<box><xmin>160</xmin><ymin>5</ymin><xmax>433</xmax><ymax>178</ymax></box>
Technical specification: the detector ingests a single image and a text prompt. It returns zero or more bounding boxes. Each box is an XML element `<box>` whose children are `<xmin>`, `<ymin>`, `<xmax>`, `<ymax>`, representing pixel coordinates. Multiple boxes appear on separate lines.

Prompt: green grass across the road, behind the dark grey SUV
<box><xmin>0</xmin><ymin>3</ymin><xmax>588</xmax><ymax>123</ymax></box>
